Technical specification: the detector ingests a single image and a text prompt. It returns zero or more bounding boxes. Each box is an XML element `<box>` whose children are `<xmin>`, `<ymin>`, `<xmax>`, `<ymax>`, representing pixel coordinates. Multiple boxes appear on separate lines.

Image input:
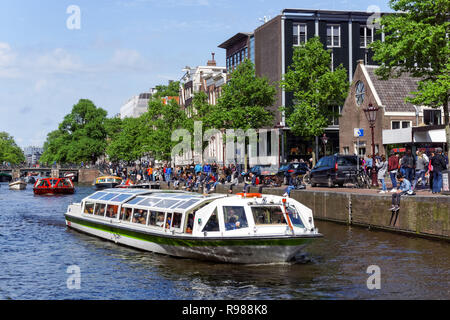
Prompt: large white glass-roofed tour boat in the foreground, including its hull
<box><xmin>65</xmin><ymin>188</ymin><xmax>322</xmax><ymax>264</ymax></box>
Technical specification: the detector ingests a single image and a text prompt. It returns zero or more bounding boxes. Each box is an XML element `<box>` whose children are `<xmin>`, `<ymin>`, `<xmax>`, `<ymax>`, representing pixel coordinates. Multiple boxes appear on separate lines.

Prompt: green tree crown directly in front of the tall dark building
<box><xmin>280</xmin><ymin>37</ymin><xmax>349</xmax><ymax>137</ymax></box>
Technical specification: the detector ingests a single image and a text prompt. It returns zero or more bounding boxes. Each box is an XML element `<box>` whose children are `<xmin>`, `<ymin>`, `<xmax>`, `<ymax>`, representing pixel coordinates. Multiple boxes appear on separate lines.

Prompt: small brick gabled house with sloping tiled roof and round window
<box><xmin>339</xmin><ymin>60</ymin><xmax>445</xmax><ymax>156</ymax></box>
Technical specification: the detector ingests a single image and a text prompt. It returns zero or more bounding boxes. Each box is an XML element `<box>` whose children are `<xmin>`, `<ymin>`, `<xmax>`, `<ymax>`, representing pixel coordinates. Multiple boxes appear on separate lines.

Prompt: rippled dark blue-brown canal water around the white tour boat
<box><xmin>0</xmin><ymin>183</ymin><xmax>450</xmax><ymax>300</ymax></box>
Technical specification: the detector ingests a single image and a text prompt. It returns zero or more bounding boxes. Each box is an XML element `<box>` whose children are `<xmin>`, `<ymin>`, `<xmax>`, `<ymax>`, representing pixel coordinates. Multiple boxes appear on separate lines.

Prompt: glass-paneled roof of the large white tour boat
<box><xmin>83</xmin><ymin>188</ymin><xmax>226</xmax><ymax>212</ymax></box>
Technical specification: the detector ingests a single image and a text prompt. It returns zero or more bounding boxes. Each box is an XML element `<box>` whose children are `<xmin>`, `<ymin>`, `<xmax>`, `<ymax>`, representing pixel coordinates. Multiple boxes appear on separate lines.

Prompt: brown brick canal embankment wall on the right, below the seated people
<box><xmin>161</xmin><ymin>183</ymin><xmax>450</xmax><ymax>240</ymax></box>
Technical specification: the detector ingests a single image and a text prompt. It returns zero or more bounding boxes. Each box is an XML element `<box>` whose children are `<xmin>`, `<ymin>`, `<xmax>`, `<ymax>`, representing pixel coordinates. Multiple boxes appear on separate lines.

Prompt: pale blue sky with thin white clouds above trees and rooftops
<box><xmin>0</xmin><ymin>0</ymin><xmax>392</xmax><ymax>148</ymax></box>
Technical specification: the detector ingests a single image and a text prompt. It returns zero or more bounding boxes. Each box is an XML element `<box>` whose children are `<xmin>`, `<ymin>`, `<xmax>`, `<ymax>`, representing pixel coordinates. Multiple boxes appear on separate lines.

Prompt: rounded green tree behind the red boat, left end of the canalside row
<box><xmin>40</xmin><ymin>99</ymin><xmax>107</xmax><ymax>163</ymax></box>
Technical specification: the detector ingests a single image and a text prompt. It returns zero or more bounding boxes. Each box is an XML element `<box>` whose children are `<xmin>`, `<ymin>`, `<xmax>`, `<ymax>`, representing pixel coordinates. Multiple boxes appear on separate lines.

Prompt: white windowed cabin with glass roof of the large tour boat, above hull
<box><xmin>77</xmin><ymin>189</ymin><xmax>314</xmax><ymax>237</ymax></box>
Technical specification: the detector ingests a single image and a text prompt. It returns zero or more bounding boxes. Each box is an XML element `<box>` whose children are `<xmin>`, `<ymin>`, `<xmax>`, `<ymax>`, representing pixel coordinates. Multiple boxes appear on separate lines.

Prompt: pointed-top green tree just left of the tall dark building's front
<box><xmin>214</xmin><ymin>59</ymin><xmax>276</xmax><ymax>130</ymax></box>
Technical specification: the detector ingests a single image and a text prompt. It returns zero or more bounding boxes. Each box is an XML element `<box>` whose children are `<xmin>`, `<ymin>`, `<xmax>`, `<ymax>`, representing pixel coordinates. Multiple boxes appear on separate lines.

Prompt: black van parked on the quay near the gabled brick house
<box><xmin>310</xmin><ymin>154</ymin><xmax>358</xmax><ymax>188</ymax></box>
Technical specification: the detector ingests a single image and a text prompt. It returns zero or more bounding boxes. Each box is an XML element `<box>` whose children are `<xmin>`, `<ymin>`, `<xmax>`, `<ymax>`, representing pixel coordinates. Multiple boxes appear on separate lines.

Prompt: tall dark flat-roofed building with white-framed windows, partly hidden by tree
<box><xmin>219</xmin><ymin>9</ymin><xmax>385</xmax><ymax>164</ymax></box>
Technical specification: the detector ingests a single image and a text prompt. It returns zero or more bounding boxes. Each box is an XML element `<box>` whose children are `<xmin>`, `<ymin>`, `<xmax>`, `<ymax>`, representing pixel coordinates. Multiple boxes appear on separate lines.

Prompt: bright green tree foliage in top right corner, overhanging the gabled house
<box><xmin>371</xmin><ymin>0</ymin><xmax>450</xmax><ymax>137</ymax></box>
